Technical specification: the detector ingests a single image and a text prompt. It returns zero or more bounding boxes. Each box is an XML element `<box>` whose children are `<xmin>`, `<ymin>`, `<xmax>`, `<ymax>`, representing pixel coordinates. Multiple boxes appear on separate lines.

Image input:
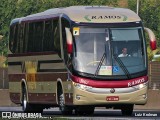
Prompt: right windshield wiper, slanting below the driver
<box><xmin>113</xmin><ymin>55</ymin><xmax>131</xmax><ymax>79</ymax></box>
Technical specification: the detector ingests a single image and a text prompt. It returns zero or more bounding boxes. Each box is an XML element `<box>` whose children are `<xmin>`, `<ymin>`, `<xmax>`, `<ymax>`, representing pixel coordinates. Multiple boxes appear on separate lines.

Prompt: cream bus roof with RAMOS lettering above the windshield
<box><xmin>15</xmin><ymin>6</ymin><xmax>141</xmax><ymax>23</ymax></box>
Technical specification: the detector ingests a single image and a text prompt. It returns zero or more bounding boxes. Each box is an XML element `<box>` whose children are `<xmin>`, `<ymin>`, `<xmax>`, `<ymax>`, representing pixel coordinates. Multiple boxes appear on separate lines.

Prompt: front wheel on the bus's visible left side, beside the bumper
<box><xmin>58</xmin><ymin>89</ymin><xmax>73</xmax><ymax>115</ymax></box>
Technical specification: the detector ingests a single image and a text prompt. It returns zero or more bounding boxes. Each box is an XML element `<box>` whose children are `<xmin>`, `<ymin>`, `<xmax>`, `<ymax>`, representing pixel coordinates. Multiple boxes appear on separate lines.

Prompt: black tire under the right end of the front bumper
<box><xmin>121</xmin><ymin>105</ymin><xmax>134</xmax><ymax>116</ymax></box>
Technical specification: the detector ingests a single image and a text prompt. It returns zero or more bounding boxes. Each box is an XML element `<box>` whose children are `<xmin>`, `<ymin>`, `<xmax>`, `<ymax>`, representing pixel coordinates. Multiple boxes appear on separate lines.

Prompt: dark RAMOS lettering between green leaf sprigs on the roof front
<box><xmin>84</xmin><ymin>15</ymin><xmax>128</xmax><ymax>22</ymax></box>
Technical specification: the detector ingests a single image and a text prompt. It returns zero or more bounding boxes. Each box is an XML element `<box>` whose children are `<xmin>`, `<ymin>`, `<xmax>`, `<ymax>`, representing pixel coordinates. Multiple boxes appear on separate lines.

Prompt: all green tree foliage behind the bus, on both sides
<box><xmin>0</xmin><ymin>0</ymin><xmax>160</xmax><ymax>63</ymax></box>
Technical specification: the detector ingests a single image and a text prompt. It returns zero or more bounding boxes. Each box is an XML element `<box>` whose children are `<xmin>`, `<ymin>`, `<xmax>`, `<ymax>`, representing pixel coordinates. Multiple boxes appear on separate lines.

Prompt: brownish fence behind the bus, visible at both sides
<box><xmin>0</xmin><ymin>61</ymin><xmax>160</xmax><ymax>89</ymax></box>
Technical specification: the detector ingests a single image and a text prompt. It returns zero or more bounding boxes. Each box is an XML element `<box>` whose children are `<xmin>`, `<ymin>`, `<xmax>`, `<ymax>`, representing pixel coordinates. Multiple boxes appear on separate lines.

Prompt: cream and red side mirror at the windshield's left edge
<box><xmin>65</xmin><ymin>28</ymin><xmax>73</xmax><ymax>54</ymax></box>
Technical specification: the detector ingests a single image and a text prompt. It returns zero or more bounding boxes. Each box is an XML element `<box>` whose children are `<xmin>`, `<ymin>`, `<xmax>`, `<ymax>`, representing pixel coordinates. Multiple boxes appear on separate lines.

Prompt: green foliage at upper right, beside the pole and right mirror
<box><xmin>128</xmin><ymin>0</ymin><xmax>160</xmax><ymax>46</ymax></box>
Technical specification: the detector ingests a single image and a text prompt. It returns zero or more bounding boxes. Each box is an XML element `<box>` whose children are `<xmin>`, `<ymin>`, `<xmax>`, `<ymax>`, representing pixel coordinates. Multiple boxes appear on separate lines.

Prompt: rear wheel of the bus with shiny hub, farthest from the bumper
<box><xmin>22</xmin><ymin>87</ymin><xmax>43</xmax><ymax>113</ymax></box>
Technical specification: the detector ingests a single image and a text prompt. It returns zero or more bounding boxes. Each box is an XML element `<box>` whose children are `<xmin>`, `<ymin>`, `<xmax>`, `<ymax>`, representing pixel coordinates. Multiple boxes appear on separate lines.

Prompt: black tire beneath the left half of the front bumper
<box><xmin>75</xmin><ymin>106</ymin><xmax>94</xmax><ymax>115</ymax></box>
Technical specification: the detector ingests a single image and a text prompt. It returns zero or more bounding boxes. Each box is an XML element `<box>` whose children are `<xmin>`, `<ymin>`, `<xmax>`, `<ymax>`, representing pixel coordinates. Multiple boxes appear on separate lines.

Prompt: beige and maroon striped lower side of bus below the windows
<box><xmin>8</xmin><ymin>53</ymin><xmax>67</xmax><ymax>104</ymax></box>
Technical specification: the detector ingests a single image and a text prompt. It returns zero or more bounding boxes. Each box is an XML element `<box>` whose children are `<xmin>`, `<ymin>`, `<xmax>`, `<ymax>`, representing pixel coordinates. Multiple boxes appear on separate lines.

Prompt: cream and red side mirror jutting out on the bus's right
<box><xmin>144</xmin><ymin>27</ymin><xmax>157</xmax><ymax>50</ymax></box>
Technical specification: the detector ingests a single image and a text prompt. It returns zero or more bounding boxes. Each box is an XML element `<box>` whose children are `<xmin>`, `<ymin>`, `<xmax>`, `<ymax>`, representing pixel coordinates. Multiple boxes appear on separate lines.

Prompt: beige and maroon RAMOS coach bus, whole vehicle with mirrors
<box><xmin>8</xmin><ymin>6</ymin><xmax>156</xmax><ymax>115</ymax></box>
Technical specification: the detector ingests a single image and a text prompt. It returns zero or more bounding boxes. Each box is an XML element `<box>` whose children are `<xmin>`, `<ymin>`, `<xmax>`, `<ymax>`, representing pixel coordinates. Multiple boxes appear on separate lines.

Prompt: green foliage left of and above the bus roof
<box><xmin>0</xmin><ymin>0</ymin><xmax>118</xmax><ymax>59</ymax></box>
